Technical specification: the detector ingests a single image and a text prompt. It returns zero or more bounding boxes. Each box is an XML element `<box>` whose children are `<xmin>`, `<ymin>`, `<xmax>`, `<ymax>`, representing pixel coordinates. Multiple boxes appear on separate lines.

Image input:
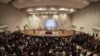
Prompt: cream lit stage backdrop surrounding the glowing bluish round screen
<box><xmin>28</xmin><ymin>14</ymin><xmax>71</xmax><ymax>30</ymax></box>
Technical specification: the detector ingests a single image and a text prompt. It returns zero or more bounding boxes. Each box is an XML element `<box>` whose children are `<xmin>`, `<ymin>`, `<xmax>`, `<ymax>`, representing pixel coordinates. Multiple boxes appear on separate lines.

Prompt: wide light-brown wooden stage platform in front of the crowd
<box><xmin>21</xmin><ymin>29</ymin><xmax>80</xmax><ymax>36</ymax></box>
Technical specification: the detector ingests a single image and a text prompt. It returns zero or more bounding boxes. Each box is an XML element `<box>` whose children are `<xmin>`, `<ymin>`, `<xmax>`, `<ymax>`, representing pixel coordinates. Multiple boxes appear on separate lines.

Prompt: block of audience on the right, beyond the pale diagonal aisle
<box><xmin>72</xmin><ymin>33</ymin><xmax>100</xmax><ymax>53</ymax></box>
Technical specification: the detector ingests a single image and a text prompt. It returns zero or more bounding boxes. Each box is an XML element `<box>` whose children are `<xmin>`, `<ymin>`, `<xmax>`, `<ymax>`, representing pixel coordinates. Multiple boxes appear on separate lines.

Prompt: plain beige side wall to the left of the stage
<box><xmin>0</xmin><ymin>3</ymin><xmax>27</xmax><ymax>32</ymax></box>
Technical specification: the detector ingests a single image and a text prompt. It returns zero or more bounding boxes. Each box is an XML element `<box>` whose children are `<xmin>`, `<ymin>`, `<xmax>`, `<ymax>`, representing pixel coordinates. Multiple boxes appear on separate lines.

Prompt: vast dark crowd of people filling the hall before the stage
<box><xmin>0</xmin><ymin>32</ymin><xmax>100</xmax><ymax>56</ymax></box>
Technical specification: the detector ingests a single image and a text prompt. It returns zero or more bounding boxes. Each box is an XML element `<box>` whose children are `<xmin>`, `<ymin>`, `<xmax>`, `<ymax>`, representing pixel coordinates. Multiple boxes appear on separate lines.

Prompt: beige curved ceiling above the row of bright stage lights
<box><xmin>0</xmin><ymin>0</ymin><xmax>98</xmax><ymax>14</ymax></box>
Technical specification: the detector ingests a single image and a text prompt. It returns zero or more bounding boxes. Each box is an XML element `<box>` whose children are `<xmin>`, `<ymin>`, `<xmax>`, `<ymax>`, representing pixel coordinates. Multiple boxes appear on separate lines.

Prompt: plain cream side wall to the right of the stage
<box><xmin>72</xmin><ymin>2</ymin><xmax>100</xmax><ymax>34</ymax></box>
